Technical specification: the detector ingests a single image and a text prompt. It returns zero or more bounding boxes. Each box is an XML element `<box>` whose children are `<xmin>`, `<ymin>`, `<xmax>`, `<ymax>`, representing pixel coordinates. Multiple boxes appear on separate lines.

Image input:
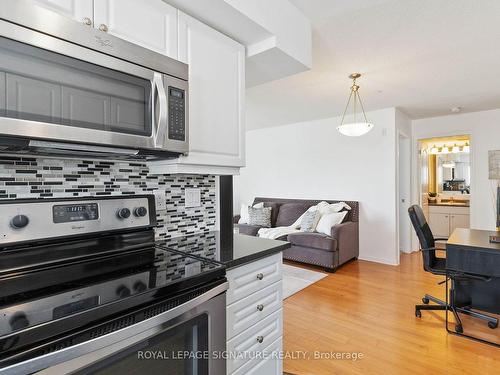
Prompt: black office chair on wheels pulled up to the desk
<box><xmin>408</xmin><ymin>205</ymin><xmax>498</xmax><ymax>333</ymax></box>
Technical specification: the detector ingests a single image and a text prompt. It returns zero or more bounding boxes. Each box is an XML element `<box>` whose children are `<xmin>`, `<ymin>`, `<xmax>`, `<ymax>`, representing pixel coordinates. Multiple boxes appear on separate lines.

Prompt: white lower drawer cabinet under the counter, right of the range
<box><xmin>226</xmin><ymin>254</ymin><xmax>283</xmax><ymax>375</ymax></box>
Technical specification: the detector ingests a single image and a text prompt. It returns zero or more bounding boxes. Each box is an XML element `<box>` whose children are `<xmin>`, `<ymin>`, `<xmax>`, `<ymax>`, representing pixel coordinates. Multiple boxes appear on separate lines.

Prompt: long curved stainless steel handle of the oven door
<box><xmin>0</xmin><ymin>281</ymin><xmax>229</xmax><ymax>375</ymax></box>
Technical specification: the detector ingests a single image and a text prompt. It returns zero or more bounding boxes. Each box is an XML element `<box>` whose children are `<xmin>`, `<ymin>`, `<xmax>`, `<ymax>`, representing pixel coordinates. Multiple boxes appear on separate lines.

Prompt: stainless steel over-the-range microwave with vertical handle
<box><xmin>0</xmin><ymin>7</ymin><xmax>187</xmax><ymax>153</ymax></box>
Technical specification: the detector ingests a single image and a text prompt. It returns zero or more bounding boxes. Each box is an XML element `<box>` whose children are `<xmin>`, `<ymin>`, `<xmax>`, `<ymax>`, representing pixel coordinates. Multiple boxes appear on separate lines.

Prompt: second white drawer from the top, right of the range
<box><xmin>226</xmin><ymin>281</ymin><xmax>283</xmax><ymax>339</ymax></box>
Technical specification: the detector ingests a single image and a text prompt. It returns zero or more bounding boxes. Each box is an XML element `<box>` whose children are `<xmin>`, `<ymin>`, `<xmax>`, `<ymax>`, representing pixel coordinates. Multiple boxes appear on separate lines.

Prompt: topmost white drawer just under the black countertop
<box><xmin>226</xmin><ymin>253</ymin><xmax>283</xmax><ymax>305</ymax></box>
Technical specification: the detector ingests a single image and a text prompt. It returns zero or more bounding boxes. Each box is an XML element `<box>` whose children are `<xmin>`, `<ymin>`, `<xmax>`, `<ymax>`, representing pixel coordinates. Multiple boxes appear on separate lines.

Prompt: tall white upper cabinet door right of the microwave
<box><xmin>179</xmin><ymin>11</ymin><xmax>245</xmax><ymax>167</ymax></box>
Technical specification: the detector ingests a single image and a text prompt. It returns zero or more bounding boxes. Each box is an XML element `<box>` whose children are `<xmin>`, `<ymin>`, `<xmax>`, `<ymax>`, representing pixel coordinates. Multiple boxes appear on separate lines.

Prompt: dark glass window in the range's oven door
<box><xmin>73</xmin><ymin>314</ymin><xmax>209</xmax><ymax>375</ymax></box>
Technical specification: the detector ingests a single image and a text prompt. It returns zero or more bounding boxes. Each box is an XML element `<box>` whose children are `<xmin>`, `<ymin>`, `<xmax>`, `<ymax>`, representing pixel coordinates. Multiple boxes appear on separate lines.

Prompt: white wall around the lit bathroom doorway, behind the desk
<box><xmin>412</xmin><ymin>109</ymin><xmax>500</xmax><ymax>230</ymax></box>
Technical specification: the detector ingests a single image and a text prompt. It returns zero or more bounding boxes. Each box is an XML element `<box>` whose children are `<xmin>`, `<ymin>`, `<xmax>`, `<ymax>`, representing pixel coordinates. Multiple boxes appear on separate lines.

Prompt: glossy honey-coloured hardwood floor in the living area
<box><xmin>284</xmin><ymin>252</ymin><xmax>500</xmax><ymax>375</ymax></box>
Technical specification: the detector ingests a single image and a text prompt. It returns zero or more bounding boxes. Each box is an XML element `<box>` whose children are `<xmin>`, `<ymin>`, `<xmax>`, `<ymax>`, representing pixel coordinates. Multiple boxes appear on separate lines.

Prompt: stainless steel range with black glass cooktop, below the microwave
<box><xmin>0</xmin><ymin>195</ymin><xmax>227</xmax><ymax>375</ymax></box>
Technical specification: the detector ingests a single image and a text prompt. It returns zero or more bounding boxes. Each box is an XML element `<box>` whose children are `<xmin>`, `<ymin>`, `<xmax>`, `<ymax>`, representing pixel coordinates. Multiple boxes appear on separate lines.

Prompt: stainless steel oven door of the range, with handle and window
<box><xmin>1</xmin><ymin>282</ymin><xmax>227</xmax><ymax>375</ymax></box>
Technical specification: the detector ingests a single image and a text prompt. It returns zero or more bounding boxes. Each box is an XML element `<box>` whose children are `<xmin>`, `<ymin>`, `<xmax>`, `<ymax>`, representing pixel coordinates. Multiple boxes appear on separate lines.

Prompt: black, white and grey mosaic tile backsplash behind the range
<box><xmin>0</xmin><ymin>155</ymin><xmax>216</xmax><ymax>239</ymax></box>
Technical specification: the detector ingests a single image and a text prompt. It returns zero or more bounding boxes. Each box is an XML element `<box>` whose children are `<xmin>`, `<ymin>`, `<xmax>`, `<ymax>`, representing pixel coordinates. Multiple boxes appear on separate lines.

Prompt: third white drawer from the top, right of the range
<box><xmin>227</xmin><ymin>309</ymin><xmax>283</xmax><ymax>373</ymax></box>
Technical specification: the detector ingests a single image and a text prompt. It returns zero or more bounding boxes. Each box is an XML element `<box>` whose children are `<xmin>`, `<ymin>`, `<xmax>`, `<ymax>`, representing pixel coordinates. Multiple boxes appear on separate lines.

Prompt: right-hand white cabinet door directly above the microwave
<box><xmin>94</xmin><ymin>0</ymin><xmax>177</xmax><ymax>59</ymax></box>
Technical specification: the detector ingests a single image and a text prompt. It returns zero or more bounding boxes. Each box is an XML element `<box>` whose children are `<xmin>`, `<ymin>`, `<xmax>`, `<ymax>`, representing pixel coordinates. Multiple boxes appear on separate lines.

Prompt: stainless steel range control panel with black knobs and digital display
<box><xmin>0</xmin><ymin>195</ymin><xmax>156</xmax><ymax>246</ymax></box>
